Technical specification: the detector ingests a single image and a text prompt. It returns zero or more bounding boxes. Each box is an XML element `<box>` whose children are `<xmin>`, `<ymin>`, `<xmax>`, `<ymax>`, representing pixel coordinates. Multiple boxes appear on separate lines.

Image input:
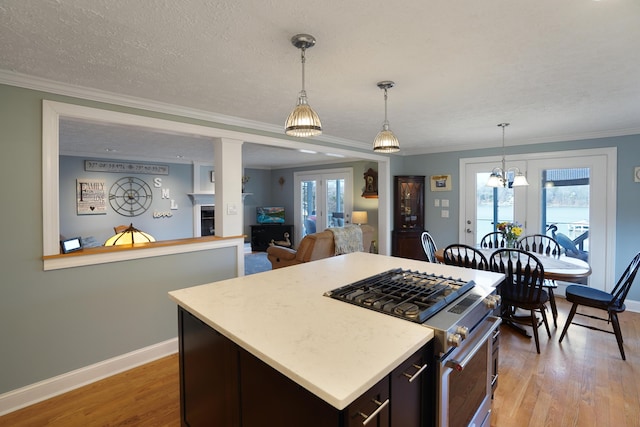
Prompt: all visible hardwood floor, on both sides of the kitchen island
<box><xmin>0</xmin><ymin>298</ymin><xmax>640</xmax><ymax>427</ymax></box>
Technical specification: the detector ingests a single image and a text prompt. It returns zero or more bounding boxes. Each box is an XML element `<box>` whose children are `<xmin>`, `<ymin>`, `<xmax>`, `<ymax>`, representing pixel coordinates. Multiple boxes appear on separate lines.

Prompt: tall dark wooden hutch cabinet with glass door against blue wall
<box><xmin>391</xmin><ymin>175</ymin><xmax>427</xmax><ymax>261</ymax></box>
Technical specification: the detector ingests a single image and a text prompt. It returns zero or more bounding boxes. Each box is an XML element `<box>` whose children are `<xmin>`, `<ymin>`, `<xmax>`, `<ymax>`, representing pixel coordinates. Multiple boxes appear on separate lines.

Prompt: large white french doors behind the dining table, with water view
<box><xmin>460</xmin><ymin>149</ymin><xmax>616</xmax><ymax>290</ymax></box>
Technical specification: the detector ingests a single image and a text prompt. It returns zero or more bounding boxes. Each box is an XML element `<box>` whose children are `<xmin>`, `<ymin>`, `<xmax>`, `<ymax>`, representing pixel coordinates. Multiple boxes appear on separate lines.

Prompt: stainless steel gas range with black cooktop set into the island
<box><xmin>325</xmin><ymin>268</ymin><xmax>500</xmax><ymax>427</ymax></box>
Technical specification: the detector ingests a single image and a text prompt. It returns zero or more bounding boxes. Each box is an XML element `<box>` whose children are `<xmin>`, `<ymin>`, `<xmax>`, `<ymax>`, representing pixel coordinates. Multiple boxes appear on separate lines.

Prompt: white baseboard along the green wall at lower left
<box><xmin>0</xmin><ymin>338</ymin><xmax>178</xmax><ymax>416</ymax></box>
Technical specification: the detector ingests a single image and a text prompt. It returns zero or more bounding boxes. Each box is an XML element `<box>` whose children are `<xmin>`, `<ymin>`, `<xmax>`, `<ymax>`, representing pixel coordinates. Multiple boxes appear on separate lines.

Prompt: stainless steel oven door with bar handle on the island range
<box><xmin>438</xmin><ymin>316</ymin><xmax>500</xmax><ymax>427</ymax></box>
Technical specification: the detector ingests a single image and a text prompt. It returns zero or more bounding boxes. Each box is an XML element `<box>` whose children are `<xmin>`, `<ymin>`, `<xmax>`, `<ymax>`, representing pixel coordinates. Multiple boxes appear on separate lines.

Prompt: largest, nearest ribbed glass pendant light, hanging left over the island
<box><xmin>284</xmin><ymin>34</ymin><xmax>322</xmax><ymax>137</ymax></box>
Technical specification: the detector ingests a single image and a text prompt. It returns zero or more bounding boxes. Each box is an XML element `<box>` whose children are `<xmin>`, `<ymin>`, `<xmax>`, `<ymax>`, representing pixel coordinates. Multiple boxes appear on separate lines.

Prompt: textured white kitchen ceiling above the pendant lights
<box><xmin>0</xmin><ymin>0</ymin><xmax>640</xmax><ymax>167</ymax></box>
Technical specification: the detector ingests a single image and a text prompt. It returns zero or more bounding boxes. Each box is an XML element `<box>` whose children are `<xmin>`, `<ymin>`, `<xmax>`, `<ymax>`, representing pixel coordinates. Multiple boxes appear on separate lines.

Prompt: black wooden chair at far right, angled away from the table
<box><xmin>560</xmin><ymin>252</ymin><xmax>640</xmax><ymax>360</ymax></box>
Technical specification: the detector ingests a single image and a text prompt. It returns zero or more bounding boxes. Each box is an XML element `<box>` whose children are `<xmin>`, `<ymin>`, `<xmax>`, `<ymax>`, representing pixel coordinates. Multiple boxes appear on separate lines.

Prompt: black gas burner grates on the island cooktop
<box><xmin>325</xmin><ymin>268</ymin><xmax>475</xmax><ymax>323</ymax></box>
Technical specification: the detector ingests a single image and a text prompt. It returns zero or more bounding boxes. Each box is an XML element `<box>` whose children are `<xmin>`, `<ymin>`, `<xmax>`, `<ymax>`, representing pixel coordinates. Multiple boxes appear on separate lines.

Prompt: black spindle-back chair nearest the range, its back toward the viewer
<box><xmin>489</xmin><ymin>249</ymin><xmax>551</xmax><ymax>354</ymax></box>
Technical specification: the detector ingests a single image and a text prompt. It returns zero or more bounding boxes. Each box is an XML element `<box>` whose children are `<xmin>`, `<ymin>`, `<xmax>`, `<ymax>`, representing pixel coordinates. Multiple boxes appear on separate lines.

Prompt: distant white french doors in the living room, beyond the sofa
<box><xmin>294</xmin><ymin>169</ymin><xmax>353</xmax><ymax>243</ymax></box>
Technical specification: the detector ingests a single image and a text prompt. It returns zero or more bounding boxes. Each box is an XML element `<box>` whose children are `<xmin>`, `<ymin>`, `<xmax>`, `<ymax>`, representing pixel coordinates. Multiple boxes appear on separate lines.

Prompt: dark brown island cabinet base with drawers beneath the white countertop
<box><xmin>178</xmin><ymin>307</ymin><xmax>435</xmax><ymax>427</ymax></box>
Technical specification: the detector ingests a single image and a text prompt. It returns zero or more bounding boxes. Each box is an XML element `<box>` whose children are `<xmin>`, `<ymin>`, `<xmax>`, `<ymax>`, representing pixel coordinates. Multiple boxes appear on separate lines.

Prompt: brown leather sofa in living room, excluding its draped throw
<box><xmin>267</xmin><ymin>224</ymin><xmax>373</xmax><ymax>270</ymax></box>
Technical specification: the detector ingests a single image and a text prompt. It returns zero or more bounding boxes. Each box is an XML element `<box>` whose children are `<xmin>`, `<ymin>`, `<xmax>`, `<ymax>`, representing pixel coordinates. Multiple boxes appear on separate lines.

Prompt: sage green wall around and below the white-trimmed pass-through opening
<box><xmin>0</xmin><ymin>85</ymin><xmax>237</xmax><ymax>394</ymax></box>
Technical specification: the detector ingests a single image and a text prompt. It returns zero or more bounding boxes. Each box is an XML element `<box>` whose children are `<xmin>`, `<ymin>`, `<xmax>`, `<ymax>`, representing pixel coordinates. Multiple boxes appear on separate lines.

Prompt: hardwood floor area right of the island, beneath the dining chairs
<box><xmin>491</xmin><ymin>298</ymin><xmax>640</xmax><ymax>427</ymax></box>
